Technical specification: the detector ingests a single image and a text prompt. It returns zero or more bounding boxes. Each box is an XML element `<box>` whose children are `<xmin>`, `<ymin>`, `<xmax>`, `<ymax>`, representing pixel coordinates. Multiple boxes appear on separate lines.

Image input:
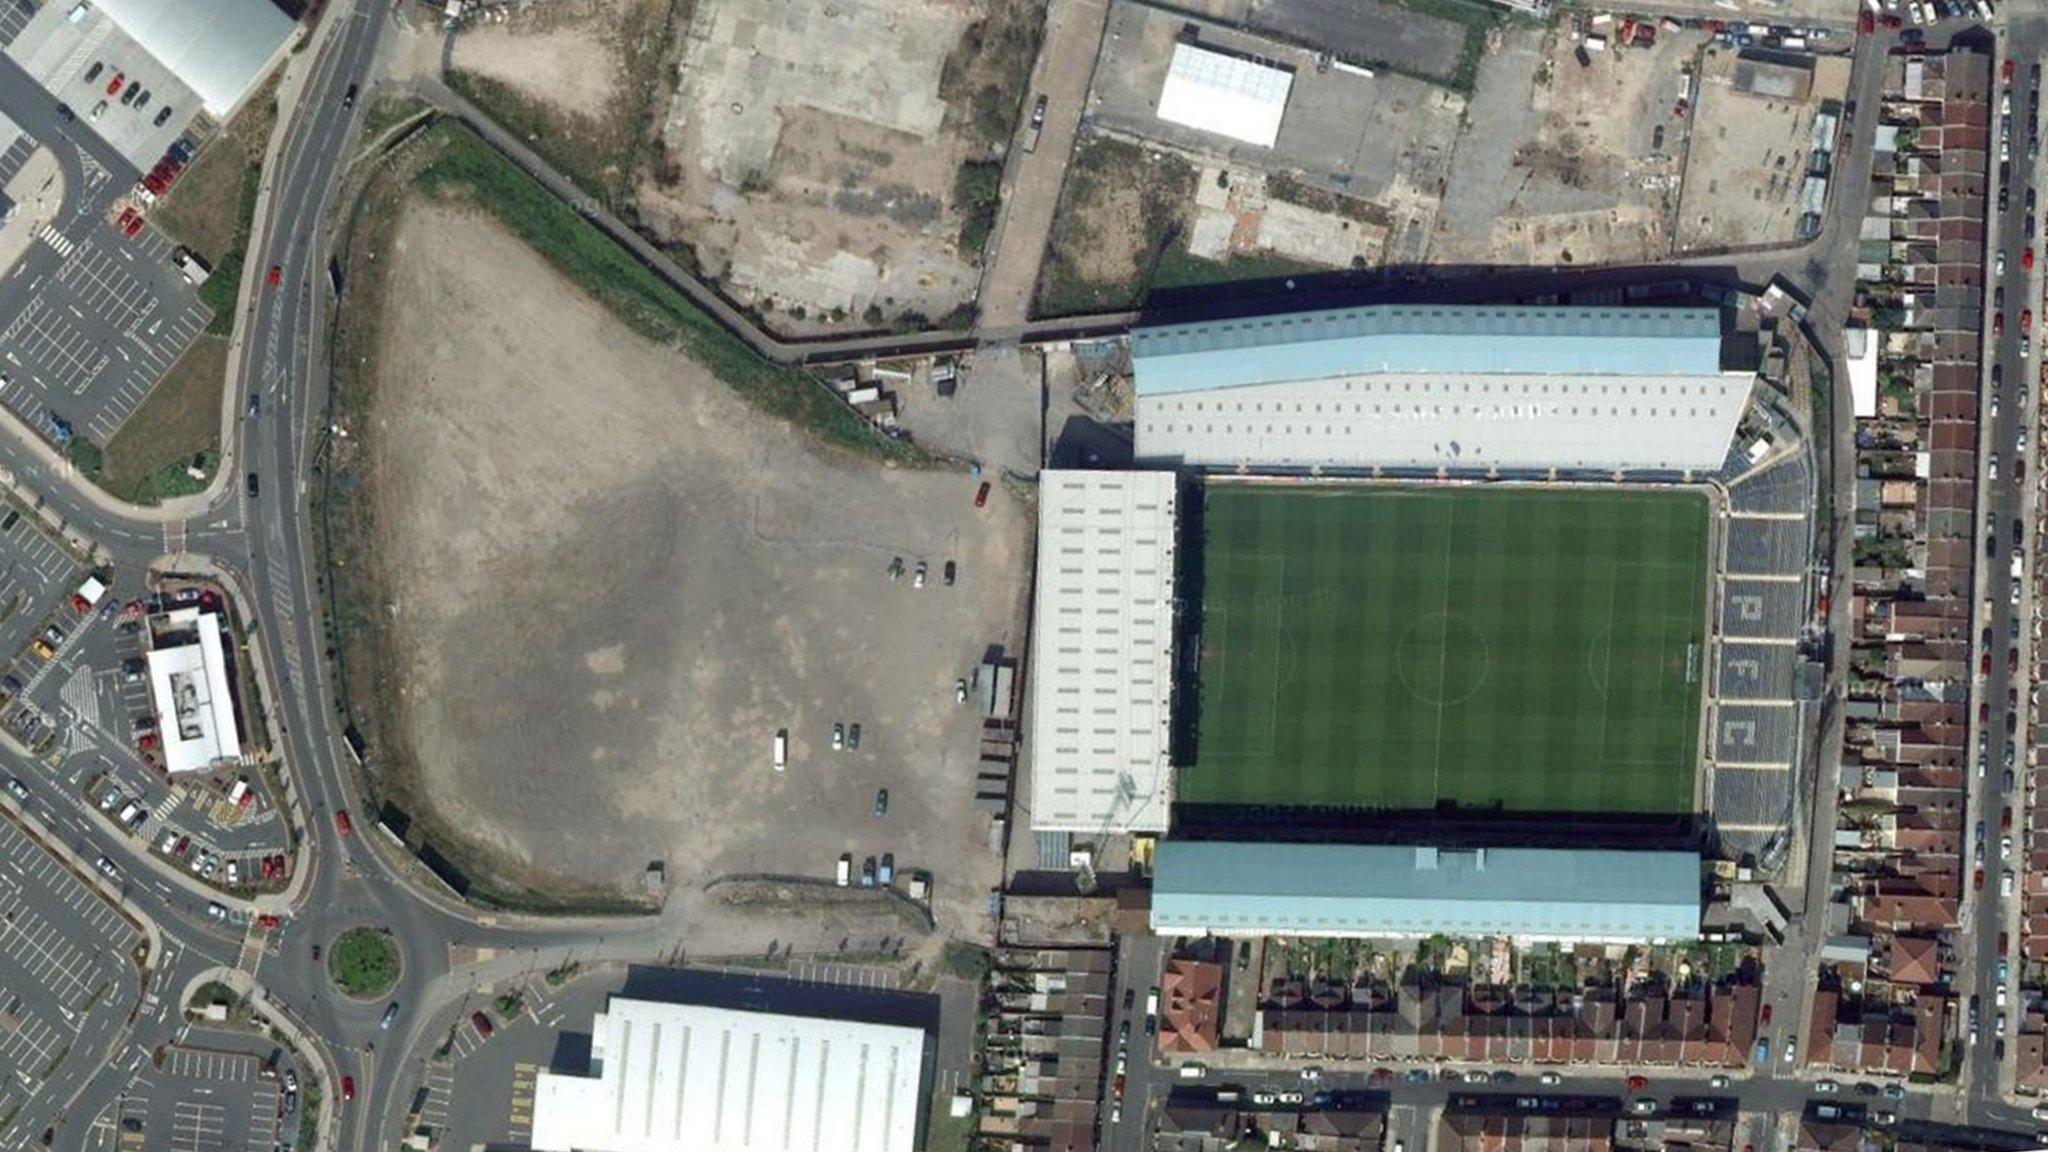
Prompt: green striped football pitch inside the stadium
<box><xmin>1178</xmin><ymin>482</ymin><xmax>1708</xmax><ymax>814</ymax></box>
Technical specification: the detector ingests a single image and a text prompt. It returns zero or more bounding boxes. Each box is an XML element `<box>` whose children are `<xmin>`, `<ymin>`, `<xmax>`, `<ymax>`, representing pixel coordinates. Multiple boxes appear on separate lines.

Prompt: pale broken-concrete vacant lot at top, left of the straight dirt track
<box><xmin>639</xmin><ymin>0</ymin><xmax>1024</xmax><ymax>332</ymax></box>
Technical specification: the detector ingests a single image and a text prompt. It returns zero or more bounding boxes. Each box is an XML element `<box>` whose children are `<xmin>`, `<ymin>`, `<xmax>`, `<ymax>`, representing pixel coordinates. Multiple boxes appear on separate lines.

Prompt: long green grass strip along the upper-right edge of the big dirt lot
<box><xmin>414</xmin><ymin>123</ymin><xmax>930</xmax><ymax>463</ymax></box>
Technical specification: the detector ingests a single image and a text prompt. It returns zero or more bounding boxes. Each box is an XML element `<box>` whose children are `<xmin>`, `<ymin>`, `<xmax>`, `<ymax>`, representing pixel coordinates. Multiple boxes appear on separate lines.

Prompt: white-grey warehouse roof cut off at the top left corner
<box><xmin>92</xmin><ymin>0</ymin><xmax>297</xmax><ymax>117</ymax></box>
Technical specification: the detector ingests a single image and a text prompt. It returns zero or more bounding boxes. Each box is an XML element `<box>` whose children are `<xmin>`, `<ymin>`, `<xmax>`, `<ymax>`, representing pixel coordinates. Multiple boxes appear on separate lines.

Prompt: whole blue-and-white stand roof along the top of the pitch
<box><xmin>1130</xmin><ymin>303</ymin><xmax>1753</xmax><ymax>471</ymax></box>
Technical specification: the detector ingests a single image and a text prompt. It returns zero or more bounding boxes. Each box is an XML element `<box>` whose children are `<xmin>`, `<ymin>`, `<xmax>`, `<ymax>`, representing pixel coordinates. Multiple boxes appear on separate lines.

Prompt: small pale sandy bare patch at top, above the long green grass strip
<box><xmin>453</xmin><ymin>0</ymin><xmax>618</xmax><ymax>117</ymax></box>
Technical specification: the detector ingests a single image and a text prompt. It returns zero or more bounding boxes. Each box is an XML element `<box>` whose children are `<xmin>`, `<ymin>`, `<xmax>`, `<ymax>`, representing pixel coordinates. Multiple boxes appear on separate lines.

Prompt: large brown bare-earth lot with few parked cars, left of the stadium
<box><xmin>369</xmin><ymin>203</ymin><xmax>1030</xmax><ymax>931</ymax></box>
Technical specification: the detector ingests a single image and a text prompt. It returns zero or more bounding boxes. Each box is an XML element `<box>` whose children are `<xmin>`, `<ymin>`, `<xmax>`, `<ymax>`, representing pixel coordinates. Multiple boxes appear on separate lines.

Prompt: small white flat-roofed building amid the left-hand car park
<box><xmin>147</xmin><ymin>609</ymin><xmax>242</xmax><ymax>773</ymax></box>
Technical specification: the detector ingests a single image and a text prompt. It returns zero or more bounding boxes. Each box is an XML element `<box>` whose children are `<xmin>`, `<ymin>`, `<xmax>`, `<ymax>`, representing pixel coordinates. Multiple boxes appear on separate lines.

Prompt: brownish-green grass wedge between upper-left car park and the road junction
<box><xmin>100</xmin><ymin>334</ymin><xmax>227</xmax><ymax>504</ymax></box>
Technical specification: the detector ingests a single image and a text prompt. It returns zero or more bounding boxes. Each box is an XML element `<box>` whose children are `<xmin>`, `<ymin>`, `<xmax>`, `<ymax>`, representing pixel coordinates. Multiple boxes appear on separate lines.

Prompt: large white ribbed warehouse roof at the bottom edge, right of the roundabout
<box><xmin>530</xmin><ymin>996</ymin><xmax>924</xmax><ymax>1152</ymax></box>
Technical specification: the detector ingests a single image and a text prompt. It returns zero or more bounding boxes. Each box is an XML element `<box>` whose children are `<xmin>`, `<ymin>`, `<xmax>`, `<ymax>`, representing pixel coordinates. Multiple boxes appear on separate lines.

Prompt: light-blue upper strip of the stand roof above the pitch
<box><xmin>1130</xmin><ymin>303</ymin><xmax>1720</xmax><ymax>396</ymax></box>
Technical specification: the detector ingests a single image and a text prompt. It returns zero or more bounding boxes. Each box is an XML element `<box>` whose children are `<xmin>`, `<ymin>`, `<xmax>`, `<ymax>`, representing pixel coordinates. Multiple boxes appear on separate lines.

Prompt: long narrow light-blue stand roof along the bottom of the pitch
<box><xmin>1151</xmin><ymin>840</ymin><xmax>1700</xmax><ymax>941</ymax></box>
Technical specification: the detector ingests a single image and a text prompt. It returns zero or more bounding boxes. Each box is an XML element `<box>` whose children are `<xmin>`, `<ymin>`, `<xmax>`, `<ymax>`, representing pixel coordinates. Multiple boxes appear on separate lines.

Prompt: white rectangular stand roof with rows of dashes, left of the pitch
<box><xmin>1030</xmin><ymin>469</ymin><xmax>1178</xmax><ymax>834</ymax></box>
